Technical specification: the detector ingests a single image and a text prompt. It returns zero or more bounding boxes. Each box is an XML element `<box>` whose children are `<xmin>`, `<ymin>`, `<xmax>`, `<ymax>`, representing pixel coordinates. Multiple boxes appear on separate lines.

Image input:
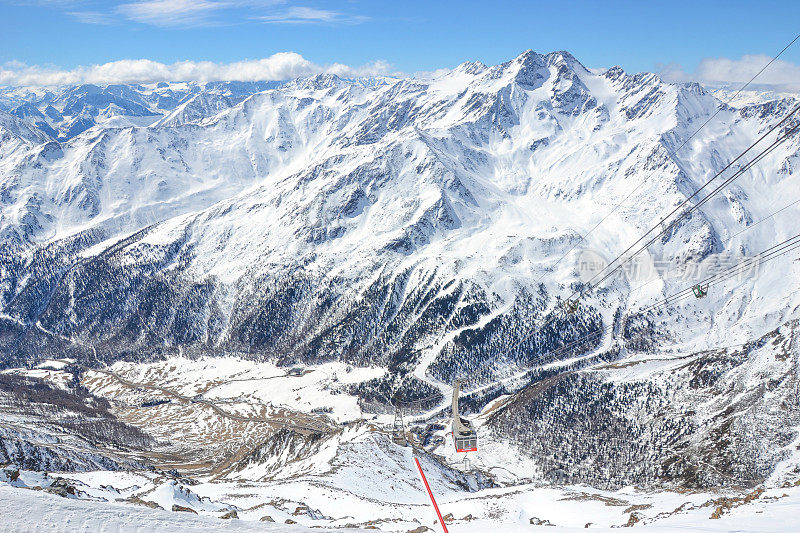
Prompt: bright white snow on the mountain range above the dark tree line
<box><xmin>0</xmin><ymin>51</ymin><xmax>800</xmax><ymax>358</ymax></box>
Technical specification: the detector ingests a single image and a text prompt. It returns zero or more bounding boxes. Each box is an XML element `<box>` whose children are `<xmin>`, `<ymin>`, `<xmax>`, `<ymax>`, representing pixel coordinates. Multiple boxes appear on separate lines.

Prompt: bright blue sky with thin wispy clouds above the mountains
<box><xmin>0</xmin><ymin>0</ymin><xmax>800</xmax><ymax>83</ymax></box>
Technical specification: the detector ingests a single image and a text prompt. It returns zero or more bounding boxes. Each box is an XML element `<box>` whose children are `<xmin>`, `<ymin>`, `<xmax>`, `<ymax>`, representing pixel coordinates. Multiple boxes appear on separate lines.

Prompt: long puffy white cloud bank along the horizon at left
<box><xmin>0</xmin><ymin>52</ymin><xmax>397</xmax><ymax>86</ymax></box>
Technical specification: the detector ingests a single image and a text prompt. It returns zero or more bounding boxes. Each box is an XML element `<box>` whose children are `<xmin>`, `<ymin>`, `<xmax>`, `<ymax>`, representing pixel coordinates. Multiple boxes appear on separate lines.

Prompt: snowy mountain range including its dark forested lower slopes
<box><xmin>0</xmin><ymin>51</ymin><xmax>800</xmax><ymax>494</ymax></box>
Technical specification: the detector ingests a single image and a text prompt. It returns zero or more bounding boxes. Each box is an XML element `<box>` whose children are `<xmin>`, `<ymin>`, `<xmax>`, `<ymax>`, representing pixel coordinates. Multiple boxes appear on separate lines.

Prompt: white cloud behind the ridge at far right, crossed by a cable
<box><xmin>659</xmin><ymin>54</ymin><xmax>800</xmax><ymax>90</ymax></box>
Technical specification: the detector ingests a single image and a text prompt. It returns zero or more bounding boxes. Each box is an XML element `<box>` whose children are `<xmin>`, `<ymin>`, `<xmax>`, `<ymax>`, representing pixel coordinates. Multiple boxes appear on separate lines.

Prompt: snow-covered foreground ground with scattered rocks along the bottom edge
<box><xmin>0</xmin><ymin>472</ymin><xmax>800</xmax><ymax>533</ymax></box>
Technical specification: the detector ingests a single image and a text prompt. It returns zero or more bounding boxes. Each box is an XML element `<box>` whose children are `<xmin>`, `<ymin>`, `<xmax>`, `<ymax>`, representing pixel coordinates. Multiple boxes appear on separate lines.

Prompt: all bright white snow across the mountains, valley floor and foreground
<box><xmin>0</xmin><ymin>48</ymin><xmax>800</xmax><ymax>533</ymax></box>
